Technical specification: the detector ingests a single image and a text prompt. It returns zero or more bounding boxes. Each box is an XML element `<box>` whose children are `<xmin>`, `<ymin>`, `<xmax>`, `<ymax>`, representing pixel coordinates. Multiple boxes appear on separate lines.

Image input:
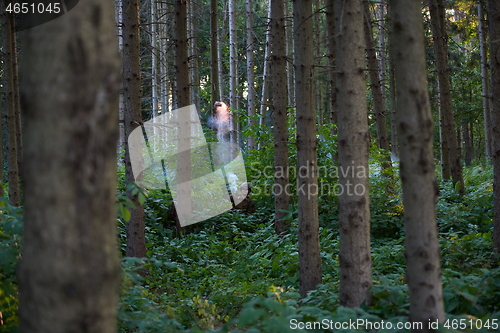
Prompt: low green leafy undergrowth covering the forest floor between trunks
<box><xmin>0</xmin><ymin>160</ymin><xmax>500</xmax><ymax>333</ymax></box>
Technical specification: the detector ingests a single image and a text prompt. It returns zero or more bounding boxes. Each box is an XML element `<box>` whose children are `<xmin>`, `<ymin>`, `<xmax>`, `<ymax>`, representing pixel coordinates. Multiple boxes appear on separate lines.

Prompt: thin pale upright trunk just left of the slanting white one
<box><xmin>246</xmin><ymin>0</ymin><xmax>256</xmax><ymax>149</ymax></box>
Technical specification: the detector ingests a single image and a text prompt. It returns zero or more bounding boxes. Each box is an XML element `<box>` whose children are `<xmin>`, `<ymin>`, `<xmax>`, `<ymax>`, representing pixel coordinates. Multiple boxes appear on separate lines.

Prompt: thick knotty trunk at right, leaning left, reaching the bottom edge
<box><xmin>391</xmin><ymin>0</ymin><xmax>445</xmax><ymax>326</ymax></box>
